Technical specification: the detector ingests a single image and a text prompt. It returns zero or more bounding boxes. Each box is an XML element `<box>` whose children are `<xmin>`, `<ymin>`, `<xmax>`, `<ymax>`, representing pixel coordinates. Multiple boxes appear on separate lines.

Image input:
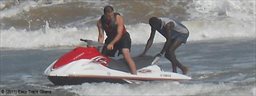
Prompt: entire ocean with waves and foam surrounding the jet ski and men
<box><xmin>0</xmin><ymin>0</ymin><xmax>256</xmax><ymax>96</ymax></box>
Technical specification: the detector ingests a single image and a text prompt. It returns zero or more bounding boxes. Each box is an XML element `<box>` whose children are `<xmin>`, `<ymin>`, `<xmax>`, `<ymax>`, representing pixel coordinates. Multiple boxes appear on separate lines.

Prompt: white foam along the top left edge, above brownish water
<box><xmin>0</xmin><ymin>0</ymin><xmax>108</xmax><ymax>19</ymax></box>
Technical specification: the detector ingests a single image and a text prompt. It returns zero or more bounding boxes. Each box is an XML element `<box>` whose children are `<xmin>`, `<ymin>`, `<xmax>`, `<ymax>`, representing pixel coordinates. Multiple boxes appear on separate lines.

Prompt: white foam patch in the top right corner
<box><xmin>187</xmin><ymin>0</ymin><xmax>256</xmax><ymax>21</ymax></box>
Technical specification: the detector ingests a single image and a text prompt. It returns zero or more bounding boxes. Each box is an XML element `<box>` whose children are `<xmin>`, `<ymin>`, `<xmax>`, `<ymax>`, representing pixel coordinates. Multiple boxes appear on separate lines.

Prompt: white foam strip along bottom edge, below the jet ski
<box><xmin>58</xmin><ymin>82</ymin><xmax>255</xmax><ymax>96</ymax></box>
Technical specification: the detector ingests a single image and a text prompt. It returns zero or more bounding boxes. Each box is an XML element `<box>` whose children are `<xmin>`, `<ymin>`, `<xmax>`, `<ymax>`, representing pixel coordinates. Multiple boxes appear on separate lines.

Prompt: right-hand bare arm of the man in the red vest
<box><xmin>108</xmin><ymin>15</ymin><xmax>124</xmax><ymax>50</ymax></box>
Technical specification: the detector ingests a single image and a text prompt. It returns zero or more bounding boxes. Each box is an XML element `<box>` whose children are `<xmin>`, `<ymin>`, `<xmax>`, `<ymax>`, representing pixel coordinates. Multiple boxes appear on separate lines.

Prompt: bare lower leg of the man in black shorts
<box><xmin>122</xmin><ymin>48</ymin><xmax>137</xmax><ymax>74</ymax></box>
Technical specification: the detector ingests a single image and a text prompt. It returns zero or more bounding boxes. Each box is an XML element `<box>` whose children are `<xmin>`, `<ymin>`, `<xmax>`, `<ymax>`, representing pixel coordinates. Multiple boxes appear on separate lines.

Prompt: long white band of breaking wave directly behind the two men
<box><xmin>0</xmin><ymin>21</ymin><xmax>256</xmax><ymax>48</ymax></box>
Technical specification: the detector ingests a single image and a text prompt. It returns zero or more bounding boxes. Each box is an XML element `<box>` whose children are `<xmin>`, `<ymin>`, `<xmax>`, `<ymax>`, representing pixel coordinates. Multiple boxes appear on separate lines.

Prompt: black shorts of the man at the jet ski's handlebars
<box><xmin>102</xmin><ymin>32</ymin><xmax>131</xmax><ymax>57</ymax></box>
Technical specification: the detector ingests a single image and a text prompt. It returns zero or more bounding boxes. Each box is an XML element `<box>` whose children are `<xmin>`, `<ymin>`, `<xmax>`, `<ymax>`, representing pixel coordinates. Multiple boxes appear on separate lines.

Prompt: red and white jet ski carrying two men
<box><xmin>44</xmin><ymin>40</ymin><xmax>191</xmax><ymax>85</ymax></box>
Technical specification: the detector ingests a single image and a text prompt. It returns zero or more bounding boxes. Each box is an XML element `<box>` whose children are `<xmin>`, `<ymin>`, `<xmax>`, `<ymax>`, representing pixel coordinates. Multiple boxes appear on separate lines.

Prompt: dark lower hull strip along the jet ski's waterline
<box><xmin>48</xmin><ymin>76</ymin><xmax>182</xmax><ymax>85</ymax></box>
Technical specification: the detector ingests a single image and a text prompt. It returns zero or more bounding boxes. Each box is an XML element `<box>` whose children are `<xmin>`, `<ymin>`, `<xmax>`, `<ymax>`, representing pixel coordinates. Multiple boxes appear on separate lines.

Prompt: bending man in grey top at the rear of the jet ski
<box><xmin>140</xmin><ymin>17</ymin><xmax>189</xmax><ymax>74</ymax></box>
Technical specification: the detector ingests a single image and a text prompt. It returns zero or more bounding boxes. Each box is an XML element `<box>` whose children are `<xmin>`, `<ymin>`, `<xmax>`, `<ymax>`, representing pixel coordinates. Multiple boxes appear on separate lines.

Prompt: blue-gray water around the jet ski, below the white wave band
<box><xmin>0</xmin><ymin>39</ymin><xmax>256</xmax><ymax>96</ymax></box>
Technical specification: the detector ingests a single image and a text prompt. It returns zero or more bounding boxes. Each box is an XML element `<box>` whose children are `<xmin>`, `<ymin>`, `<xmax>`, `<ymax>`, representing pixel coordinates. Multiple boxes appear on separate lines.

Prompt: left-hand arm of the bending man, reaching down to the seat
<box><xmin>140</xmin><ymin>28</ymin><xmax>156</xmax><ymax>56</ymax></box>
